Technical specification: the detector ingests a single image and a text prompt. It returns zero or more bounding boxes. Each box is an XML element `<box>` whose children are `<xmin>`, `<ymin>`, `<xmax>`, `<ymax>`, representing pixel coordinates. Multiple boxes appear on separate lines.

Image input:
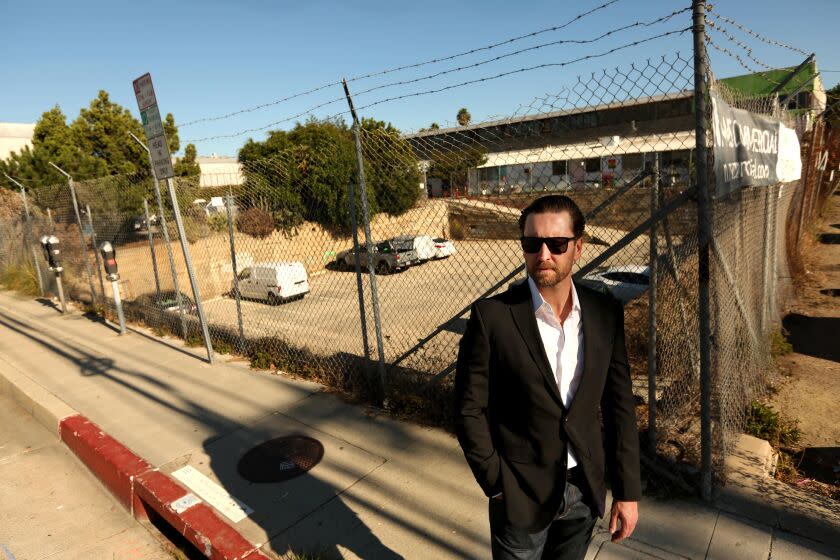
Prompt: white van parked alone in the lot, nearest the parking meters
<box><xmin>238</xmin><ymin>262</ymin><xmax>309</xmax><ymax>305</ymax></box>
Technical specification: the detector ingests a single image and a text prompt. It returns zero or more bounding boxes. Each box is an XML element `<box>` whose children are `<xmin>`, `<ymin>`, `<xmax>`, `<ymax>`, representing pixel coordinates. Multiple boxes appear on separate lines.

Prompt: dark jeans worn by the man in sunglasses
<box><xmin>490</xmin><ymin>479</ymin><xmax>596</xmax><ymax>560</ymax></box>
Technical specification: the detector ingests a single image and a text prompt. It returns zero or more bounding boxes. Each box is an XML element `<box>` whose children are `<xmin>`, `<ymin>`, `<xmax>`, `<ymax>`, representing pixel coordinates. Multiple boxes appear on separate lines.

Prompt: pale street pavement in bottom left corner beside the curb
<box><xmin>0</xmin><ymin>395</ymin><xmax>173</xmax><ymax>560</ymax></box>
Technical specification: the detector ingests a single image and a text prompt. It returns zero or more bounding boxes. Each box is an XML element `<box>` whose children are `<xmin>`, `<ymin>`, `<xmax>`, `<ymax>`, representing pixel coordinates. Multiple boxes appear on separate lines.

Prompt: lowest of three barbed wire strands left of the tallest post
<box><xmin>184</xmin><ymin>27</ymin><xmax>691</xmax><ymax>143</ymax></box>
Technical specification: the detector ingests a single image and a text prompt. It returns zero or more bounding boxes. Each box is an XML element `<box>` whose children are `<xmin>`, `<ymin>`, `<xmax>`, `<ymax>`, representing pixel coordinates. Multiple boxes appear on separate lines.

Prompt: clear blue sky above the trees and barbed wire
<box><xmin>0</xmin><ymin>0</ymin><xmax>840</xmax><ymax>155</ymax></box>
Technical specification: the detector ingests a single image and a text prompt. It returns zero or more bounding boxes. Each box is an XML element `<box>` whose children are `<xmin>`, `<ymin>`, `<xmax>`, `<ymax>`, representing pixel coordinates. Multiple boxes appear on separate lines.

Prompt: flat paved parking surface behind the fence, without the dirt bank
<box><xmin>197</xmin><ymin>223</ymin><xmax>647</xmax><ymax>370</ymax></box>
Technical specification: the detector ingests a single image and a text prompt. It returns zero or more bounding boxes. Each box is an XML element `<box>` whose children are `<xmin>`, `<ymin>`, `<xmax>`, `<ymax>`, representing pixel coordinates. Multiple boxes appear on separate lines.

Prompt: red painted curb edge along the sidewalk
<box><xmin>58</xmin><ymin>414</ymin><xmax>269</xmax><ymax>560</ymax></box>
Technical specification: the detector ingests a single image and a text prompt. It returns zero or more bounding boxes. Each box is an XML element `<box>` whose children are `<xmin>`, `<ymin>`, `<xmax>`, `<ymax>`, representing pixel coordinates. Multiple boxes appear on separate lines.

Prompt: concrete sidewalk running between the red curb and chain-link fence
<box><xmin>0</xmin><ymin>293</ymin><xmax>840</xmax><ymax>559</ymax></box>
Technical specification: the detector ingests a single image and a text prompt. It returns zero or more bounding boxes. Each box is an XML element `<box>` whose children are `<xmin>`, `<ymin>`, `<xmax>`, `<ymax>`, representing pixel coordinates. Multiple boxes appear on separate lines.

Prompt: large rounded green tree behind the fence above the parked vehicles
<box><xmin>239</xmin><ymin>119</ymin><xmax>419</xmax><ymax>232</ymax></box>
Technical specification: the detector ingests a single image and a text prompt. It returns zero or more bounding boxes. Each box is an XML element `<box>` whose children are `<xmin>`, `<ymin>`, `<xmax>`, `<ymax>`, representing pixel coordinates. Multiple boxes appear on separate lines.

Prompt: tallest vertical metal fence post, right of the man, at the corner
<box><xmin>691</xmin><ymin>0</ymin><xmax>712</xmax><ymax>501</ymax></box>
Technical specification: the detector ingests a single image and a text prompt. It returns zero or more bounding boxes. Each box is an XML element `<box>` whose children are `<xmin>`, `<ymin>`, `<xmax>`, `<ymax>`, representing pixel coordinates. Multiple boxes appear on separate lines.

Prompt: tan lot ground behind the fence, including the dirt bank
<box><xmin>88</xmin><ymin>200</ymin><xmax>648</xmax><ymax>371</ymax></box>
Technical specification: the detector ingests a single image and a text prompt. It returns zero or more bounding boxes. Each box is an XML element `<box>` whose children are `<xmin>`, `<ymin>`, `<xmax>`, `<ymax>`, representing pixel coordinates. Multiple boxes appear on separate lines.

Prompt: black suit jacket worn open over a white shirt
<box><xmin>455</xmin><ymin>282</ymin><xmax>641</xmax><ymax>532</ymax></box>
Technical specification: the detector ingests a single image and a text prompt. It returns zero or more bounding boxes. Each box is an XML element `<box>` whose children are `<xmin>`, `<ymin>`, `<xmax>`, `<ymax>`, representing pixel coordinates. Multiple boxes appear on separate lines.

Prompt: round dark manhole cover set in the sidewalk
<box><xmin>236</xmin><ymin>436</ymin><xmax>324</xmax><ymax>482</ymax></box>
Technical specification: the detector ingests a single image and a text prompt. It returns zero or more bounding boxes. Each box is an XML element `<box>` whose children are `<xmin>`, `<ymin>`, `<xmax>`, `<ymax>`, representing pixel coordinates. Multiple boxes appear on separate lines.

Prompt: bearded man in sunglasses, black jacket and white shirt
<box><xmin>455</xmin><ymin>195</ymin><xmax>641</xmax><ymax>560</ymax></box>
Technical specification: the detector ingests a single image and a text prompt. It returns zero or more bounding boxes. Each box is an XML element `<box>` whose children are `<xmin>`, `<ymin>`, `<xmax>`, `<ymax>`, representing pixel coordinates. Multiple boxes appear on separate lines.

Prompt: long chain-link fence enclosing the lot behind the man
<box><xmin>0</xmin><ymin>3</ymin><xmax>840</xmax><ymax>494</ymax></box>
